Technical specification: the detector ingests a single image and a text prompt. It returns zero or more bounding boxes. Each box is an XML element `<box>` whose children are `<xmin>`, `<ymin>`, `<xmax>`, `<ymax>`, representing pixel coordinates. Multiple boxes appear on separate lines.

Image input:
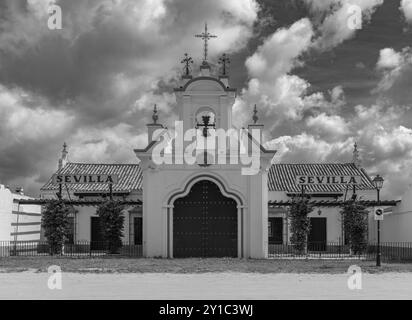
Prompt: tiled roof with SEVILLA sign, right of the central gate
<box><xmin>268</xmin><ymin>163</ymin><xmax>374</xmax><ymax>193</ymax></box>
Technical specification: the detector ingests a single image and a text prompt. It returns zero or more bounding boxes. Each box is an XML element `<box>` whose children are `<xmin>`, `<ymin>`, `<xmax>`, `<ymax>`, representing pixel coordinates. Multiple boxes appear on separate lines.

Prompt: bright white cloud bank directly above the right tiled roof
<box><xmin>266</xmin><ymin>105</ymin><xmax>412</xmax><ymax>198</ymax></box>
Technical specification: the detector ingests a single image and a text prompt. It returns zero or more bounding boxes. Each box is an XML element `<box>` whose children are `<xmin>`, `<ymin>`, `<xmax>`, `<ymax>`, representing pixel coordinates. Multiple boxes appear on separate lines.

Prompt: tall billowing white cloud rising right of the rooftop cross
<box><xmin>234</xmin><ymin>19</ymin><xmax>313</xmax><ymax>126</ymax></box>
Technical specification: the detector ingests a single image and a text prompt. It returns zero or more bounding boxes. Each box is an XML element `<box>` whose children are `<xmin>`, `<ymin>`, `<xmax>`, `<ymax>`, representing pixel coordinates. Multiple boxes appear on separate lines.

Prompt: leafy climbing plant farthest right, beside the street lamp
<box><xmin>341</xmin><ymin>201</ymin><xmax>368</xmax><ymax>254</ymax></box>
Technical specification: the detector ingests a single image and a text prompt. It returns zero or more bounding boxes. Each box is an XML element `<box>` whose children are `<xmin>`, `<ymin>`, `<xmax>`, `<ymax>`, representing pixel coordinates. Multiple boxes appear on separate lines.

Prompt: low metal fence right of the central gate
<box><xmin>269</xmin><ymin>242</ymin><xmax>412</xmax><ymax>262</ymax></box>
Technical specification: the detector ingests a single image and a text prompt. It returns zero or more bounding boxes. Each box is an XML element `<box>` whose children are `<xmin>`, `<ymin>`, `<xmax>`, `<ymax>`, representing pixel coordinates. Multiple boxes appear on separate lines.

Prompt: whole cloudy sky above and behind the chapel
<box><xmin>0</xmin><ymin>0</ymin><xmax>412</xmax><ymax>198</ymax></box>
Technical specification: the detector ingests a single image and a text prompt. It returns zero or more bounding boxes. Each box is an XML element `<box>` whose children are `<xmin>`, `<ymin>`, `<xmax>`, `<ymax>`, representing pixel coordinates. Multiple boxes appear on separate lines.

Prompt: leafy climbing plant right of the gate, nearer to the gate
<box><xmin>289</xmin><ymin>198</ymin><xmax>313</xmax><ymax>253</ymax></box>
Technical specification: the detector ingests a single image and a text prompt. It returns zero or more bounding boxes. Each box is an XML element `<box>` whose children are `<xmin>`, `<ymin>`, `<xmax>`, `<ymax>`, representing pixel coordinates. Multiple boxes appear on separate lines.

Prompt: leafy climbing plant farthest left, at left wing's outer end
<box><xmin>42</xmin><ymin>200</ymin><xmax>76</xmax><ymax>255</ymax></box>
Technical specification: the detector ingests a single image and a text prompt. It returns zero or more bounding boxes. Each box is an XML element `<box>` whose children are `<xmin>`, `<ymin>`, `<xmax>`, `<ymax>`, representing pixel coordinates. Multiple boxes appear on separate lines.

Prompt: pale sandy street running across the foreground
<box><xmin>0</xmin><ymin>272</ymin><xmax>412</xmax><ymax>299</ymax></box>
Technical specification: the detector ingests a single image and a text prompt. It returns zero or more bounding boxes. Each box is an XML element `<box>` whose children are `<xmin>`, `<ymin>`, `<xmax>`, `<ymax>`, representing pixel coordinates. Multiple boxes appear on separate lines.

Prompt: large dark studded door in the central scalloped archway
<box><xmin>173</xmin><ymin>180</ymin><xmax>238</xmax><ymax>258</ymax></box>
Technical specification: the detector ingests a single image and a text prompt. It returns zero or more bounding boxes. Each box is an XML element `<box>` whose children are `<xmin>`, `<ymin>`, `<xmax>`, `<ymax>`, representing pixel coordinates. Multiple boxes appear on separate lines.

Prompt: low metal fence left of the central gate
<box><xmin>0</xmin><ymin>241</ymin><xmax>143</xmax><ymax>258</ymax></box>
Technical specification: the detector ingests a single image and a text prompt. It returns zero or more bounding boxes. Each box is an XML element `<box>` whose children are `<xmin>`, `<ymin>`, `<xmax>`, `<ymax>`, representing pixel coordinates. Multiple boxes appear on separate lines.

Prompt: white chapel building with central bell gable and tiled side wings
<box><xmin>41</xmin><ymin>36</ymin><xmax>375</xmax><ymax>258</ymax></box>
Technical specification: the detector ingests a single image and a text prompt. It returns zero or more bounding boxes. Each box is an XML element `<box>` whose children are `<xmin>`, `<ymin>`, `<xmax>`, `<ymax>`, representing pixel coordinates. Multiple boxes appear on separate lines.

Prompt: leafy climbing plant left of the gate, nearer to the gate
<box><xmin>97</xmin><ymin>200</ymin><xmax>124</xmax><ymax>254</ymax></box>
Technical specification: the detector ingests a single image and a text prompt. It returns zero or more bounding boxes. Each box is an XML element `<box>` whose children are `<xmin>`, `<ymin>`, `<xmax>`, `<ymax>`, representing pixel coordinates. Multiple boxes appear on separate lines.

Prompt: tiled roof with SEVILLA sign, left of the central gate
<box><xmin>41</xmin><ymin>163</ymin><xmax>142</xmax><ymax>192</ymax></box>
